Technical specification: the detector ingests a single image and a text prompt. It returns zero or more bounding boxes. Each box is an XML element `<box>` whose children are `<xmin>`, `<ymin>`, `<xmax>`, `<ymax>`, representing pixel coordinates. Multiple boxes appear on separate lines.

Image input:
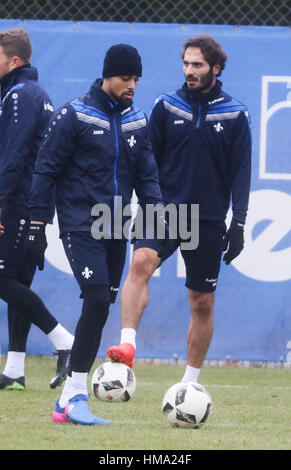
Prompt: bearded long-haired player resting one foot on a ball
<box><xmin>107</xmin><ymin>35</ymin><xmax>251</xmax><ymax>382</ymax></box>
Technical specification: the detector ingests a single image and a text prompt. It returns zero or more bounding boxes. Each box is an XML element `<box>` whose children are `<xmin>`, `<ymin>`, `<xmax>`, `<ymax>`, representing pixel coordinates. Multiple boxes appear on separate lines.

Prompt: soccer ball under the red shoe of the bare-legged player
<box><xmin>92</xmin><ymin>362</ymin><xmax>136</xmax><ymax>402</ymax></box>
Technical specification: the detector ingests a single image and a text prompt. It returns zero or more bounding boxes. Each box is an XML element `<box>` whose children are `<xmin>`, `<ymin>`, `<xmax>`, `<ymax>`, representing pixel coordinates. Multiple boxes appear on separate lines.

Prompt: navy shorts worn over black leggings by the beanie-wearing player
<box><xmin>61</xmin><ymin>232</ymin><xmax>126</xmax><ymax>303</ymax></box>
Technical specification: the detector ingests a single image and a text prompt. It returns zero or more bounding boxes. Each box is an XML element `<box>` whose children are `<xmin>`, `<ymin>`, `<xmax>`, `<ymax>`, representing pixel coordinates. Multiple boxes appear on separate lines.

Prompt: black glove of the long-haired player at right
<box><xmin>222</xmin><ymin>219</ymin><xmax>244</xmax><ymax>264</ymax></box>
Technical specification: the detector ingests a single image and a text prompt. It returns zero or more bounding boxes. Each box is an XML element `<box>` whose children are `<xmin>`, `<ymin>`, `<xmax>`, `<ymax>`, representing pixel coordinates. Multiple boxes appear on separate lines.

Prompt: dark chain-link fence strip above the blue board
<box><xmin>0</xmin><ymin>0</ymin><xmax>291</xmax><ymax>26</ymax></box>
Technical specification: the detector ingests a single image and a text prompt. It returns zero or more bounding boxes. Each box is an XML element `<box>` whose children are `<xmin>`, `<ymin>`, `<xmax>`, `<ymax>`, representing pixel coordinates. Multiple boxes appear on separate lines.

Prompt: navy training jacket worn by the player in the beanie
<box><xmin>30</xmin><ymin>80</ymin><xmax>162</xmax><ymax>234</ymax></box>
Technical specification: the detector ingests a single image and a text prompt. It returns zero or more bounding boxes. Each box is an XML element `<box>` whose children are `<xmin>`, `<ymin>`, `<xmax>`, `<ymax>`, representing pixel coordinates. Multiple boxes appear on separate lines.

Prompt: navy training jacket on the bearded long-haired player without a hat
<box><xmin>150</xmin><ymin>80</ymin><xmax>251</xmax><ymax>223</ymax></box>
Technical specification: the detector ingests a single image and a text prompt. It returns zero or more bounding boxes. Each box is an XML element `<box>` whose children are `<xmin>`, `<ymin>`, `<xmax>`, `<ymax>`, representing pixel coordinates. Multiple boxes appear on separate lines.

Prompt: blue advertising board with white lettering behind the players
<box><xmin>0</xmin><ymin>20</ymin><xmax>291</xmax><ymax>362</ymax></box>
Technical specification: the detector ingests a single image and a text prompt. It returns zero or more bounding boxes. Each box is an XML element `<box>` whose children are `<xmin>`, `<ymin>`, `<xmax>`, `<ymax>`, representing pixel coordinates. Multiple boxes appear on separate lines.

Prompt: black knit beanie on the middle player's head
<box><xmin>103</xmin><ymin>44</ymin><xmax>142</xmax><ymax>78</ymax></box>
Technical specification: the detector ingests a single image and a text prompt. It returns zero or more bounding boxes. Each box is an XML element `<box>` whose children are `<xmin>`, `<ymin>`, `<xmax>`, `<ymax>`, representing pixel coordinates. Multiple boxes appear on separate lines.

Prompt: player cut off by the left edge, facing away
<box><xmin>0</xmin><ymin>29</ymin><xmax>73</xmax><ymax>390</ymax></box>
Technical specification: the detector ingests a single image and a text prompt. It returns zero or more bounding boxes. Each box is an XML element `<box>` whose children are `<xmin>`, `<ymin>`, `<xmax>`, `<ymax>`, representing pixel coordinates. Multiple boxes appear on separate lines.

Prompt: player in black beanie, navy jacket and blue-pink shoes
<box><xmin>30</xmin><ymin>44</ymin><xmax>162</xmax><ymax>425</ymax></box>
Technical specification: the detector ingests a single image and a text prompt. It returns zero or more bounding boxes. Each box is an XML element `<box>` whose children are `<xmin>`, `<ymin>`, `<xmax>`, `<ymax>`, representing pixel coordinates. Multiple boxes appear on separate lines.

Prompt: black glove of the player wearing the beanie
<box><xmin>26</xmin><ymin>223</ymin><xmax>47</xmax><ymax>271</ymax></box>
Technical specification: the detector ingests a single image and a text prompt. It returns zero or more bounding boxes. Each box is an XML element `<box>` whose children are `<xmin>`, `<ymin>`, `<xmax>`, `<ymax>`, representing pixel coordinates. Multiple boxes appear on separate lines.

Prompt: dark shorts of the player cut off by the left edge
<box><xmin>0</xmin><ymin>210</ymin><xmax>36</xmax><ymax>285</ymax></box>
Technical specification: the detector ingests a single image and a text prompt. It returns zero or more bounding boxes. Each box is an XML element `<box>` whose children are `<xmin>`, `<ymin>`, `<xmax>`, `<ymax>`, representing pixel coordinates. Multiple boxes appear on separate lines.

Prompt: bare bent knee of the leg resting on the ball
<box><xmin>129</xmin><ymin>248</ymin><xmax>160</xmax><ymax>281</ymax></box>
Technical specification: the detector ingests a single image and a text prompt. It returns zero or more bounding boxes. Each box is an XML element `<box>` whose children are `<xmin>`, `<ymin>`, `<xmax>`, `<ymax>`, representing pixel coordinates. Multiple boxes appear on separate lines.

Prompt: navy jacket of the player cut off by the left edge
<box><xmin>0</xmin><ymin>65</ymin><xmax>53</xmax><ymax>216</ymax></box>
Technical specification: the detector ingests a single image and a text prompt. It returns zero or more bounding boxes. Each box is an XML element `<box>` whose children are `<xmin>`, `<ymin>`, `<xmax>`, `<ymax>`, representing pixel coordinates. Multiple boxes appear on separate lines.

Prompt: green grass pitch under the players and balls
<box><xmin>0</xmin><ymin>356</ymin><xmax>291</xmax><ymax>450</ymax></box>
